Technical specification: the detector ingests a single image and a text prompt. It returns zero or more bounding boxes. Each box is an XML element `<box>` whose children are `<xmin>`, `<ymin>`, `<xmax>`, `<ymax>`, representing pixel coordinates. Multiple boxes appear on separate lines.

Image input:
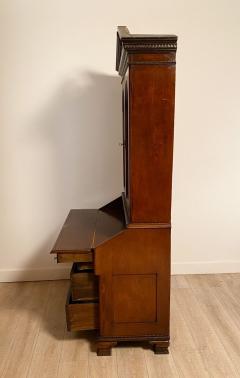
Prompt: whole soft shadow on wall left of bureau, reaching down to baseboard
<box><xmin>12</xmin><ymin>72</ymin><xmax>122</xmax><ymax>281</ymax></box>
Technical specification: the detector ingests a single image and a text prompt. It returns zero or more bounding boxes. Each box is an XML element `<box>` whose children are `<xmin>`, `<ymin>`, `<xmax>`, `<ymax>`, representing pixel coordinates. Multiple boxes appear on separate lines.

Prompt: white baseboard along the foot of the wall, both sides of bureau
<box><xmin>0</xmin><ymin>260</ymin><xmax>240</xmax><ymax>282</ymax></box>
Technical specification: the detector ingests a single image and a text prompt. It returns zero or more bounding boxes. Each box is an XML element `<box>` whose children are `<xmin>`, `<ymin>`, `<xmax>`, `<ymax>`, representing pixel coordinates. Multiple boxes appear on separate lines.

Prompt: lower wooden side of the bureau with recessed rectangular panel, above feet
<box><xmin>95</xmin><ymin>229</ymin><xmax>170</xmax><ymax>337</ymax></box>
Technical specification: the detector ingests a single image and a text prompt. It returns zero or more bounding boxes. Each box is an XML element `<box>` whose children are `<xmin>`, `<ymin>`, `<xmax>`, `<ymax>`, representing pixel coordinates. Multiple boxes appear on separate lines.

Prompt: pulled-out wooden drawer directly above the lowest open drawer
<box><xmin>70</xmin><ymin>264</ymin><xmax>98</xmax><ymax>301</ymax></box>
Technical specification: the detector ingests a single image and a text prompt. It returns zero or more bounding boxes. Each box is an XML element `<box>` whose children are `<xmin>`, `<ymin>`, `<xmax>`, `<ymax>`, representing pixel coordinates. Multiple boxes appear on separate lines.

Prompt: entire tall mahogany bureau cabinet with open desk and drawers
<box><xmin>51</xmin><ymin>26</ymin><xmax>177</xmax><ymax>355</ymax></box>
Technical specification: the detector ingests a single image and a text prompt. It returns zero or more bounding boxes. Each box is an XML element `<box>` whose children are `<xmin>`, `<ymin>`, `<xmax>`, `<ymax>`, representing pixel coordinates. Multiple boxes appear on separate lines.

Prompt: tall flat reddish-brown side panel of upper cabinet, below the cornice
<box><xmin>129</xmin><ymin>57</ymin><xmax>175</xmax><ymax>223</ymax></box>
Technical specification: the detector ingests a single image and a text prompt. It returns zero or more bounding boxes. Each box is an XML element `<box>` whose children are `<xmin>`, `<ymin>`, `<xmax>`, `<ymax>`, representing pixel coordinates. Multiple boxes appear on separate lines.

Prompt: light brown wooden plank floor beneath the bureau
<box><xmin>0</xmin><ymin>274</ymin><xmax>240</xmax><ymax>378</ymax></box>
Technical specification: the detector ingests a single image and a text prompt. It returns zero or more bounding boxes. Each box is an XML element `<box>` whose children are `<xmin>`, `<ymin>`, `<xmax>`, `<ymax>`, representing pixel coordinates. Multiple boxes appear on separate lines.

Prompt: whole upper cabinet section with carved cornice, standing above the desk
<box><xmin>116</xmin><ymin>26</ymin><xmax>177</xmax><ymax>227</ymax></box>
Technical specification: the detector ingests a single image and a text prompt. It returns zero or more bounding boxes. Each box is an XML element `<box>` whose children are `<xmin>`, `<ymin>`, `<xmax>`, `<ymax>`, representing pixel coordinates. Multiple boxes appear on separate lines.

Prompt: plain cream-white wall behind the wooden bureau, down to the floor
<box><xmin>0</xmin><ymin>0</ymin><xmax>240</xmax><ymax>281</ymax></box>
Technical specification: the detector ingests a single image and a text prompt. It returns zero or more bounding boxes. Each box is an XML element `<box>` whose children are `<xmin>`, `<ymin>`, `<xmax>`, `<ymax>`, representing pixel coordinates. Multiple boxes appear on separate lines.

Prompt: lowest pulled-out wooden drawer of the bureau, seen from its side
<box><xmin>66</xmin><ymin>293</ymin><xmax>99</xmax><ymax>331</ymax></box>
